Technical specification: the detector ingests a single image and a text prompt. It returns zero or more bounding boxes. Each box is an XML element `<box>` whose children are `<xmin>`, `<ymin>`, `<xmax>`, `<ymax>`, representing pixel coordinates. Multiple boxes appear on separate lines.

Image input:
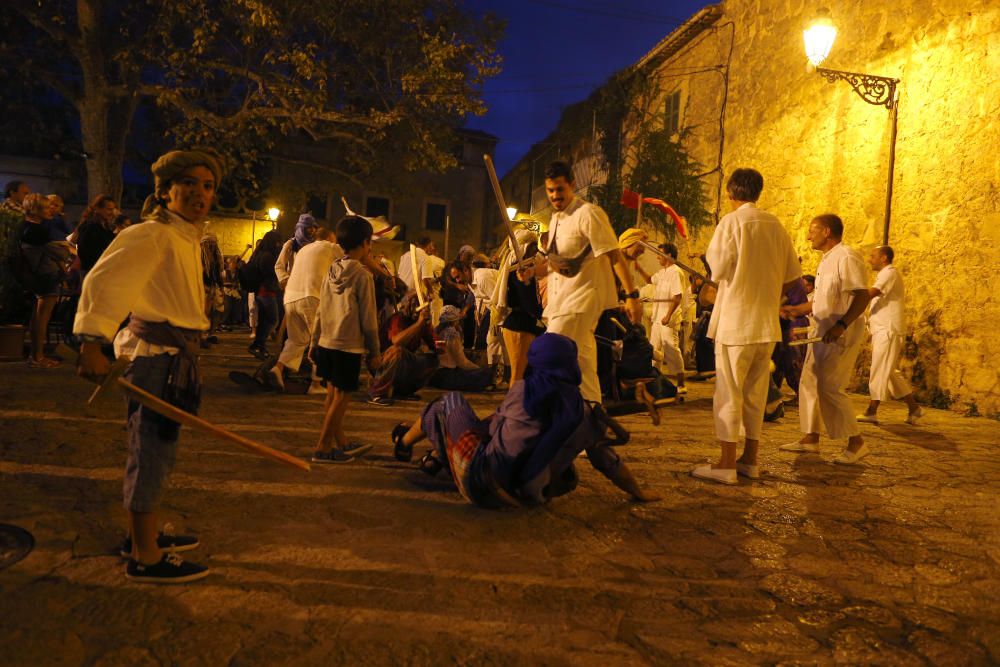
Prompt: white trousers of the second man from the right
<box><xmin>799</xmin><ymin>322</ymin><xmax>865</xmax><ymax>439</ymax></box>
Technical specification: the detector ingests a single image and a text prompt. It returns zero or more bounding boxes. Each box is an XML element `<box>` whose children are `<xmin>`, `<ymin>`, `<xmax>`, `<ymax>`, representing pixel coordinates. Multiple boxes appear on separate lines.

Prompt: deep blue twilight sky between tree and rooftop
<box><xmin>466</xmin><ymin>0</ymin><xmax>712</xmax><ymax>176</ymax></box>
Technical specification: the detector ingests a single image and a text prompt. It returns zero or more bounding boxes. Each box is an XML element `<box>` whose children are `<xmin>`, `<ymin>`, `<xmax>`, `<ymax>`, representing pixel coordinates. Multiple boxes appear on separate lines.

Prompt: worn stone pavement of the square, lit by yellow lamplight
<box><xmin>0</xmin><ymin>334</ymin><xmax>1000</xmax><ymax>667</ymax></box>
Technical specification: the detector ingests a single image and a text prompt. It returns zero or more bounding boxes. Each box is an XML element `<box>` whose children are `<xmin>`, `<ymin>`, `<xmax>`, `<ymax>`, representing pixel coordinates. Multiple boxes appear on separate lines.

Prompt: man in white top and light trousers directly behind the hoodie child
<box><xmin>269</xmin><ymin>227</ymin><xmax>344</xmax><ymax>393</ymax></box>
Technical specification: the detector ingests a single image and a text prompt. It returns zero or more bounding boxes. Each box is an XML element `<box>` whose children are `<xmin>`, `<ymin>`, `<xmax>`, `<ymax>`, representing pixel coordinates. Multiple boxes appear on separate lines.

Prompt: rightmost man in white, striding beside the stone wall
<box><xmin>858</xmin><ymin>245</ymin><xmax>924</xmax><ymax>424</ymax></box>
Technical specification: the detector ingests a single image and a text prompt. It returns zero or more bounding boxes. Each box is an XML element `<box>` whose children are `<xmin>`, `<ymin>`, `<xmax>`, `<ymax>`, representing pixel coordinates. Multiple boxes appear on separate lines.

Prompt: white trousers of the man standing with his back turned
<box><xmin>712</xmin><ymin>343</ymin><xmax>774</xmax><ymax>442</ymax></box>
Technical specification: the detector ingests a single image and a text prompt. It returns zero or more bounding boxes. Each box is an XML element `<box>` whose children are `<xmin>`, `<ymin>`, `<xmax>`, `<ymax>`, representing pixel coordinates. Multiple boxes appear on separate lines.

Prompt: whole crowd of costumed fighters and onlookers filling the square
<box><xmin>3</xmin><ymin>150</ymin><xmax>922</xmax><ymax>583</ymax></box>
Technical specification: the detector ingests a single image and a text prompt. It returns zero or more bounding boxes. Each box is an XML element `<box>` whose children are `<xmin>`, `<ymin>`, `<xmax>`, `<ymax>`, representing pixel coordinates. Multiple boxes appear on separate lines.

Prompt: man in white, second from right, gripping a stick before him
<box><xmin>779</xmin><ymin>213</ymin><xmax>869</xmax><ymax>464</ymax></box>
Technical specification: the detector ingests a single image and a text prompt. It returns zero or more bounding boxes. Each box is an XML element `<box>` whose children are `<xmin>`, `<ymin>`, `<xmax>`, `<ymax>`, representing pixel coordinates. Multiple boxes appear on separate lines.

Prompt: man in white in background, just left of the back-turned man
<box><xmin>649</xmin><ymin>243</ymin><xmax>687</xmax><ymax>394</ymax></box>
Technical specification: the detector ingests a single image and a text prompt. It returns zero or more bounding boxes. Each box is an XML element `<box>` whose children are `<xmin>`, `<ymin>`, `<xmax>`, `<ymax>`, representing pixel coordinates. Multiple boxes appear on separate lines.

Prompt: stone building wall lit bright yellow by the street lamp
<box><xmin>504</xmin><ymin>0</ymin><xmax>1000</xmax><ymax>416</ymax></box>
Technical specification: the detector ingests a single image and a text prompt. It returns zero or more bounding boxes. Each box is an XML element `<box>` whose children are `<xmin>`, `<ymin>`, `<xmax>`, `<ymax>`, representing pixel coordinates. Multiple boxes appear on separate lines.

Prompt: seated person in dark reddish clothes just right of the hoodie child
<box><xmin>368</xmin><ymin>292</ymin><xmax>437</xmax><ymax>406</ymax></box>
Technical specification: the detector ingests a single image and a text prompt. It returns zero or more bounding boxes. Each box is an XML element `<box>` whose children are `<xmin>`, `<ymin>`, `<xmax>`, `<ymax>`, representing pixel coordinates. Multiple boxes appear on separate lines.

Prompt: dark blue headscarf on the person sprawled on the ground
<box><xmin>520</xmin><ymin>333</ymin><xmax>583</xmax><ymax>482</ymax></box>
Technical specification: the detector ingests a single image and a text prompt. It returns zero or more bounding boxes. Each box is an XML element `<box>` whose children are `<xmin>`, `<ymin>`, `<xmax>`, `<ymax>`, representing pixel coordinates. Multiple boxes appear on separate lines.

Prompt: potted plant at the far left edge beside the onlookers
<box><xmin>0</xmin><ymin>209</ymin><xmax>31</xmax><ymax>361</ymax></box>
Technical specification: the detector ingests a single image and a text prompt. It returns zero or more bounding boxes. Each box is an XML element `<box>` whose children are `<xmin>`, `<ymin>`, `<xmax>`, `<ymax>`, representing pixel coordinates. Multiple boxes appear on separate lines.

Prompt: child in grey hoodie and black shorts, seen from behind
<box><xmin>309</xmin><ymin>215</ymin><xmax>382</xmax><ymax>463</ymax></box>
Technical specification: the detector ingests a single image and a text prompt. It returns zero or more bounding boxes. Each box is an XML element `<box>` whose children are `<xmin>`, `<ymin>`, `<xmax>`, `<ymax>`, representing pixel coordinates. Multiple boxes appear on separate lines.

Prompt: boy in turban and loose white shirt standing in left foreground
<box><xmin>73</xmin><ymin>151</ymin><xmax>222</xmax><ymax>583</ymax></box>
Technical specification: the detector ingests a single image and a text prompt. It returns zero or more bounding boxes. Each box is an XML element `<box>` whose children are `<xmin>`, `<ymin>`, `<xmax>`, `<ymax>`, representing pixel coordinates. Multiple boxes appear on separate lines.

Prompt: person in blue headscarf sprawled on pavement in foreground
<box><xmin>392</xmin><ymin>334</ymin><xmax>659</xmax><ymax>508</ymax></box>
